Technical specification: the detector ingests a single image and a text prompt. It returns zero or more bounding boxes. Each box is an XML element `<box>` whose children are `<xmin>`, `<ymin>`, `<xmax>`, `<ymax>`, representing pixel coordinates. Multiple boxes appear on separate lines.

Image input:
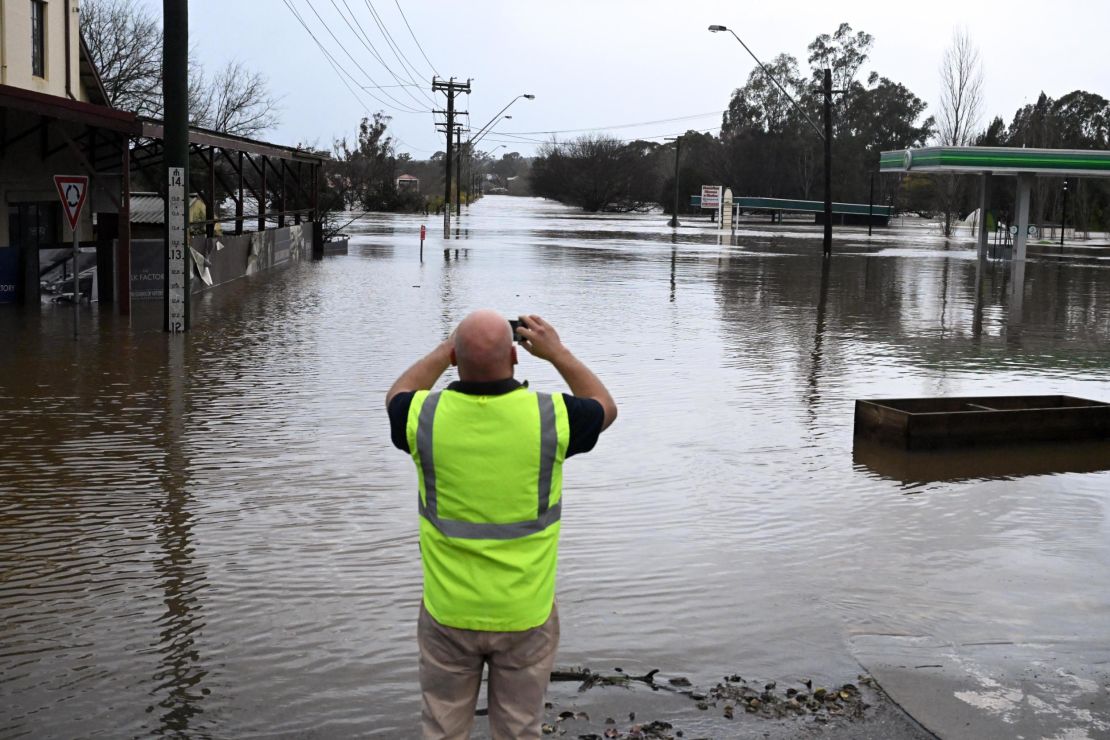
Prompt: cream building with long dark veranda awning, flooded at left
<box><xmin>0</xmin><ymin>0</ymin><xmax>330</xmax><ymax>313</ymax></box>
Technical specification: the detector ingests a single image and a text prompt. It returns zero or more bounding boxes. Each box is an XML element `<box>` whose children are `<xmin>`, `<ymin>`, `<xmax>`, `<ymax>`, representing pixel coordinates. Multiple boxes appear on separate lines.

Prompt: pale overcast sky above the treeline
<box><xmin>164</xmin><ymin>0</ymin><xmax>1110</xmax><ymax>159</ymax></box>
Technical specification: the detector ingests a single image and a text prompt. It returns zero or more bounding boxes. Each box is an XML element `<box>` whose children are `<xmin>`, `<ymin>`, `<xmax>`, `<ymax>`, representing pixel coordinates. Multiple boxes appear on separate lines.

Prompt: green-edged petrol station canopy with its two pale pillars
<box><xmin>879</xmin><ymin>146</ymin><xmax>1110</xmax><ymax>260</ymax></box>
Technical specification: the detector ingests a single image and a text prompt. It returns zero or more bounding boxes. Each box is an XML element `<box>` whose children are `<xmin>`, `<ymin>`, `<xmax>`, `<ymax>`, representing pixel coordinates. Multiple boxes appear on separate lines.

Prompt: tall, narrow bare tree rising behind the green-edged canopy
<box><xmin>937</xmin><ymin>29</ymin><xmax>983</xmax><ymax>236</ymax></box>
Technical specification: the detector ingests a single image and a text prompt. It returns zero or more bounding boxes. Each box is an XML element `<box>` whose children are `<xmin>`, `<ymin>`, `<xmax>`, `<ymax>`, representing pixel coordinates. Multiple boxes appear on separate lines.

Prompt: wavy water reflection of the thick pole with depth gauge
<box><xmin>153</xmin><ymin>336</ymin><xmax>208</xmax><ymax>734</ymax></box>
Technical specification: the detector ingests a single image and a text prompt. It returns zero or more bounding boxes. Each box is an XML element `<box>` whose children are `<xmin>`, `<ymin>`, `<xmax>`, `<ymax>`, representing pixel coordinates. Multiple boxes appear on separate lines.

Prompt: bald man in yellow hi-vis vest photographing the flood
<box><xmin>385</xmin><ymin>311</ymin><xmax>617</xmax><ymax>740</ymax></box>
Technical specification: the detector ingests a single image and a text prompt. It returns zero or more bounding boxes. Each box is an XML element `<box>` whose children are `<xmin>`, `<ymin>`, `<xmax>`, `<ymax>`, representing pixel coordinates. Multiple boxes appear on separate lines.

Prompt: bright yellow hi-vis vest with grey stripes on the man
<box><xmin>405</xmin><ymin>387</ymin><xmax>571</xmax><ymax>632</ymax></box>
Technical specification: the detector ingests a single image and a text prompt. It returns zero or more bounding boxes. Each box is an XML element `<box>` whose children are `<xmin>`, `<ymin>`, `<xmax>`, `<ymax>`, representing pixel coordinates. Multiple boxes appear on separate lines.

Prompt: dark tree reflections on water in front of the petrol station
<box><xmin>715</xmin><ymin>247</ymin><xmax>1110</xmax><ymax>373</ymax></box>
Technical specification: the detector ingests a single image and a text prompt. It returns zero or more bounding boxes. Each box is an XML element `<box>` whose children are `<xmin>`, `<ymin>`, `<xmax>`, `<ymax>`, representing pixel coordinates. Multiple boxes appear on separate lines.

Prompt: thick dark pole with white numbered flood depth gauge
<box><xmin>162</xmin><ymin>0</ymin><xmax>191</xmax><ymax>333</ymax></box>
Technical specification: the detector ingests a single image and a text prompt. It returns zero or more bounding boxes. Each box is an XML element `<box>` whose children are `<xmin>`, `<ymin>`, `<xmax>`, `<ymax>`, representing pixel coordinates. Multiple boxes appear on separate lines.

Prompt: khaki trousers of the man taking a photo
<box><xmin>416</xmin><ymin>602</ymin><xmax>558</xmax><ymax>740</ymax></box>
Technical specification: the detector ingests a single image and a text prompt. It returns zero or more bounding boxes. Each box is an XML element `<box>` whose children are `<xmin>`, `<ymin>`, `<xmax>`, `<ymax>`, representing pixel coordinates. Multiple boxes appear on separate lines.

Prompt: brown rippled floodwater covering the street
<box><xmin>0</xmin><ymin>196</ymin><xmax>1110</xmax><ymax>738</ymax></box>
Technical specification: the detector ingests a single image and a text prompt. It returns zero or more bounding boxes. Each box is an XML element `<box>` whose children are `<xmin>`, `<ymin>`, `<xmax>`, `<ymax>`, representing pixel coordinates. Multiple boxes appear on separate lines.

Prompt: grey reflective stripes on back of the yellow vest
<box><xmin>416</xmin><ymin>392</ymin><xmax>563</xmax><ymax>539</ymax></box>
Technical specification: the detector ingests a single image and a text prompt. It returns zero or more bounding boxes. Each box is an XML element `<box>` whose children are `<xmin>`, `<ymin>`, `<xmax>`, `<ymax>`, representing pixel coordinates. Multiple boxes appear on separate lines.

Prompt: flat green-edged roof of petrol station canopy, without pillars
<box><xmin>879</xmin><ymin>146</ymin><xmax>1110</xmax><ymax>178</ymax></box>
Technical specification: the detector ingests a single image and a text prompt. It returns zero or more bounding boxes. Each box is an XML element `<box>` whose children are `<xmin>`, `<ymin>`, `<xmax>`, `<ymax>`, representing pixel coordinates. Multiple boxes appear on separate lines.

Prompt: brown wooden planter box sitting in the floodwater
<box><xmin>856</xmin><ymin>396</ymin><xmax>1110</xmax><ymax>449</ymax></box>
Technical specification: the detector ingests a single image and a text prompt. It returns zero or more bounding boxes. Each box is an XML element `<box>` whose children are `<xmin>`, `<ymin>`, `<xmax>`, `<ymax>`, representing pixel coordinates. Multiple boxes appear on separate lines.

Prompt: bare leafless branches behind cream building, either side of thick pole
<box><xmin>81</xmin><ymin>0</ymin><xmax>279</xmax><ymax>136</ymax></box>
